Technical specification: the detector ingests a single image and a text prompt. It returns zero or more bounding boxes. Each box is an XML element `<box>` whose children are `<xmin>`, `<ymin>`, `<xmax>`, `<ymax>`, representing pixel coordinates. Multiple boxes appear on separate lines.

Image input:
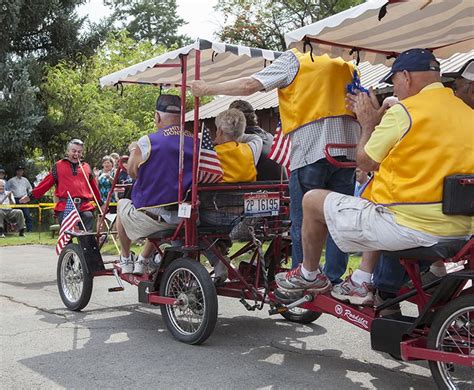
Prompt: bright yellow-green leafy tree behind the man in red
<box><xmin>39</xmin><ymin>32</ymin><xmax>191</xmax><ymax>165</ymax></box>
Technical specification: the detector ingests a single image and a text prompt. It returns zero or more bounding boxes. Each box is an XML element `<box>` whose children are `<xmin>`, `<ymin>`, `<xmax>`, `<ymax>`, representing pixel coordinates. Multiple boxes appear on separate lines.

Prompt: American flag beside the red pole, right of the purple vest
<box><xmin>198</xmin><ymin>128</ymin><xmax>224</xmax><ymax>183</ymax></box>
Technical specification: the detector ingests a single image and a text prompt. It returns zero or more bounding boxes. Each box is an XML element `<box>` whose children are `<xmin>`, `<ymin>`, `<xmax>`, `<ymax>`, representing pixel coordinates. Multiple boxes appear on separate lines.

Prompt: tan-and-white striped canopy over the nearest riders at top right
<box><xmin>285</xmin><ymin>0</ymin><xmax>474</xmax><ymax>65</ymax></box>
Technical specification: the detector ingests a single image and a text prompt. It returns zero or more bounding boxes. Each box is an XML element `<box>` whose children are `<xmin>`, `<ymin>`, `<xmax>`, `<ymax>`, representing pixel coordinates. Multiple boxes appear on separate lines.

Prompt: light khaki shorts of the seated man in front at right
<box><xmin>324</xmin><ymin>192</ymin><xmax>438</xmax><ymax>252</ymax></box>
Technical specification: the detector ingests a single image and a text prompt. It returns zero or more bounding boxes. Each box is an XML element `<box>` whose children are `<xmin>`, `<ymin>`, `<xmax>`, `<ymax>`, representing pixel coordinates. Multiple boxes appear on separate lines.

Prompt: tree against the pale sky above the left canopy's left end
<box><xmin>104</xmin><ymin>0</ymin><xmax>190</xmax><ymax>48</ymax></box>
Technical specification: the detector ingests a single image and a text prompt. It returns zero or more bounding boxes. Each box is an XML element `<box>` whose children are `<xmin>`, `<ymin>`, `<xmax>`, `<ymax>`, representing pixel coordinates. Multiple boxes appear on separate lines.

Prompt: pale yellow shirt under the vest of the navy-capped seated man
<box><xmin>362</xmin><ymin>83</ymin><xmax>474</xmax><ymax>237</ymax></box>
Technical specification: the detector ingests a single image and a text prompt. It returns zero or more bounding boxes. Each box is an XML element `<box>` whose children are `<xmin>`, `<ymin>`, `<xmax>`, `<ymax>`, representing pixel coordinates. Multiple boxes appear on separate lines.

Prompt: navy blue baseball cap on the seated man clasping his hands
<box><xmin>380</xmin><ymin>49</ymin><xmax>440</xmax><ymax>84</ymax></box>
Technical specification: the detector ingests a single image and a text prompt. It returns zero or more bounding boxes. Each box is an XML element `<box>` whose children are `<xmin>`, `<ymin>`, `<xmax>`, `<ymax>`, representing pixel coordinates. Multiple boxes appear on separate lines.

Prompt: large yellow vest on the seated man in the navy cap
<box><xmin>362</xmin><ymin>88</ymin><xmax>474</xmax><ymax>206</ymax></box>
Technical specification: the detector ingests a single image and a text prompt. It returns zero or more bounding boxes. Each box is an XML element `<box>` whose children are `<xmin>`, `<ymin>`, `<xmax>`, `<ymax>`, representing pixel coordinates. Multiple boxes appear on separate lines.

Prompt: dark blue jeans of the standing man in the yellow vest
<box><xmin>290</xmin><ymin>157</ymin><xmax>355</xmax><ymax>283</ymax></box>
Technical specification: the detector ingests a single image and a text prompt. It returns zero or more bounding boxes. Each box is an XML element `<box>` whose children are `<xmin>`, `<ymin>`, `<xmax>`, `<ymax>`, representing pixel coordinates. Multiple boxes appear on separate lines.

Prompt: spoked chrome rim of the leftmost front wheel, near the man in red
<box><xmin>61</xmin><ymin>251</ymin><xmax>84</xmax><ymax>303</ymax></box>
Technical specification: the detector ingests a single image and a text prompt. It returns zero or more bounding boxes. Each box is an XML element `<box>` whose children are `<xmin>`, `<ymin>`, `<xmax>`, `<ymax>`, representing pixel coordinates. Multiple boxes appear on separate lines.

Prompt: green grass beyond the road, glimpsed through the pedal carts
<box><xmin>0</xmin><ymin>232</ymin><xmax>360</xmax><ymax>274</ymax></box>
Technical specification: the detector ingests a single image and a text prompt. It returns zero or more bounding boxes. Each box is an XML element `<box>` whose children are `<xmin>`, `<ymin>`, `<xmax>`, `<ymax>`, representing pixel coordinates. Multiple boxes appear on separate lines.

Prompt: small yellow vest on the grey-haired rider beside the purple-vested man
<box><xmin>215</xmin><ymin>141</ymin><xmax>257</xmax><ymax>183</ymax></box>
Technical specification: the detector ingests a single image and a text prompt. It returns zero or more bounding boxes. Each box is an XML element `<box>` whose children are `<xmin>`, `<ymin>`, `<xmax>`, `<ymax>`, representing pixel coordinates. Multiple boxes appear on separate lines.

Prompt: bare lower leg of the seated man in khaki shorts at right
<box><xmin>302</xmin><ymin>190</ymin><xmax>330</xmax><ymax>272</ymax></box>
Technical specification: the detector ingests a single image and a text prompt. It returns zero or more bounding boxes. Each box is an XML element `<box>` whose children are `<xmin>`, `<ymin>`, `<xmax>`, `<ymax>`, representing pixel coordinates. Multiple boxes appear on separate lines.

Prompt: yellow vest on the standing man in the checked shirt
<box><xmin>278</xmin><ymin>49</ymin><xmax>355</xmax><ymax>134</ymax></box>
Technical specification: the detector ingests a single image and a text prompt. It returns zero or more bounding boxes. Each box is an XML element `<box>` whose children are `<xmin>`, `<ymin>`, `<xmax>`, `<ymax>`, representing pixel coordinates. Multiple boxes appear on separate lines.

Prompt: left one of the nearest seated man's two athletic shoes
<box><xmin>275</xmin><ymin>264</ymin><xmax>331</xmax><ymax>295</ymax></box>
